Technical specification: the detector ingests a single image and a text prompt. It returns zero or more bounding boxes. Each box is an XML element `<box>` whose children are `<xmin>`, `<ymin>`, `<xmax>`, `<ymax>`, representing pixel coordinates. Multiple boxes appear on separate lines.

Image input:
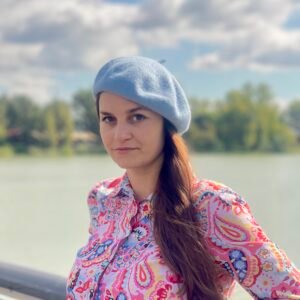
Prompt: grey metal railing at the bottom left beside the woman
<box><xmin>0</xmin><ymin>262</ymin><xmax>66</xmax><ymax>300</ymax></box>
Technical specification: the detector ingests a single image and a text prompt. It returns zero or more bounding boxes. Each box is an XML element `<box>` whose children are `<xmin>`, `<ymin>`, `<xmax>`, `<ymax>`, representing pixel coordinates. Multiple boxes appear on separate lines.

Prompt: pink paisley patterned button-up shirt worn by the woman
<box><xmin>67</xmin><ymin>173</ymin><xmax>300</xmax><ymax>300</ymax></box>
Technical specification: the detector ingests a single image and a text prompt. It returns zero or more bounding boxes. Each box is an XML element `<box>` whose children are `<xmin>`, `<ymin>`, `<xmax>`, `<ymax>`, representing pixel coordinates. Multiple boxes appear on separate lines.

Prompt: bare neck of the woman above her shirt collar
<box><xmin>127</xmin><ymin>156</ymin><xmax>162</xmax><ymax>201</ymax></box>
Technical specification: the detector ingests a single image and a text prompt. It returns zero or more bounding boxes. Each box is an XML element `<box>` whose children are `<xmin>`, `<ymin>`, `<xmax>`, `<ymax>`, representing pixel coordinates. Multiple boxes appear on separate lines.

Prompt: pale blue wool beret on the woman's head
<box><xmin>93</xmin><ymin>56</ymin><xmax>191</xmax><ymax>134</ymax></box>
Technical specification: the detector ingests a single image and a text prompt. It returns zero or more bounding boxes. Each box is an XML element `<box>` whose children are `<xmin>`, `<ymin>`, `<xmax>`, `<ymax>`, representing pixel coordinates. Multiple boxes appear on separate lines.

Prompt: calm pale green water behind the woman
<box><xmin>0</xmin><ymin>155</ymin><xmax>300</xmax><ymax>299</ymax></box>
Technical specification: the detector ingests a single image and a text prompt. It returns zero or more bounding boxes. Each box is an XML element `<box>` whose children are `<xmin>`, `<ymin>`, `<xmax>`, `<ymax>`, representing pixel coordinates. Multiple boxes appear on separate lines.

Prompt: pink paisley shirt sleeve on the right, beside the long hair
<box><xmin>197</xmin><ymin>185</ymin><xmax>300</xmax><ymax>299</ymax></box>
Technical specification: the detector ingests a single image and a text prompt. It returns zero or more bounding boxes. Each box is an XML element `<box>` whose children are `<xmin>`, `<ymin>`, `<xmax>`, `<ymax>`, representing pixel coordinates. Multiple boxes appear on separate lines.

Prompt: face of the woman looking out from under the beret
<box><xmin>99</xmin><ymin>92</ymin><xmax>164</xmax><ymax>170</ymax></box>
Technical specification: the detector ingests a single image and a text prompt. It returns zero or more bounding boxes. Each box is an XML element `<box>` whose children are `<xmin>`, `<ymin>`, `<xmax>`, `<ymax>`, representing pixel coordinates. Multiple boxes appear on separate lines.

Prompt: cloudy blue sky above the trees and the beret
<box><xmin>0</xmin><ymin>0</ymin><xmax>300</xmax><ymax>104</ymax></box>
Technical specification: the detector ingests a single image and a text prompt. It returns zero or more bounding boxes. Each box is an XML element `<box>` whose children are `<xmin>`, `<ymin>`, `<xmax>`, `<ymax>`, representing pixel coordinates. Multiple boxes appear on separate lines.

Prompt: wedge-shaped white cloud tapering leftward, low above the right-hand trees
<box><xmin>189</xmin><ymin>26</ymin><xmax>300</xmax><ymax>72</ymax></box>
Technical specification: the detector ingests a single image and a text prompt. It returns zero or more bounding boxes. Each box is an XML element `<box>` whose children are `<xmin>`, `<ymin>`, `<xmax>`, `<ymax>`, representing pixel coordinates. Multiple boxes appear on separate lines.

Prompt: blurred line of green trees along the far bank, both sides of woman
<box><xmin>0</xmin><ymin>84</ymin><xmax>300</xmax><ymax>156</ymax></box>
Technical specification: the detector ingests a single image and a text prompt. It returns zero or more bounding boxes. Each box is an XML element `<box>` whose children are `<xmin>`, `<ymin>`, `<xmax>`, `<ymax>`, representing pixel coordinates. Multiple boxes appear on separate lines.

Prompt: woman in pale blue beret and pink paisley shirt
<box><xmin>67</xmin><ymin>57</ymin><xmax>300</xmax><ymax>299</ymax></box>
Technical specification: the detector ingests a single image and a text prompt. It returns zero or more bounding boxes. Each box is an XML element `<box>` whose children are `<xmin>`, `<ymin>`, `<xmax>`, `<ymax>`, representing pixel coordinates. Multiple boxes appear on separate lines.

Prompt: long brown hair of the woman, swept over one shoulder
<box><xmin>153</xmin><ymin>120</ymin><xmax>223</xmax><ymax>300</ymax></box>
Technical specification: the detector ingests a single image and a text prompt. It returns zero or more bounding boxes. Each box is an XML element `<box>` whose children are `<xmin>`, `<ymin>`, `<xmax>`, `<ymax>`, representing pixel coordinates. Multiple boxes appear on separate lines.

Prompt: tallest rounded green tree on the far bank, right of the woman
<box><xmin>217</xmin><ymin>84</ymin><xmax>294</xmax><ymax>151</ymax></box>
